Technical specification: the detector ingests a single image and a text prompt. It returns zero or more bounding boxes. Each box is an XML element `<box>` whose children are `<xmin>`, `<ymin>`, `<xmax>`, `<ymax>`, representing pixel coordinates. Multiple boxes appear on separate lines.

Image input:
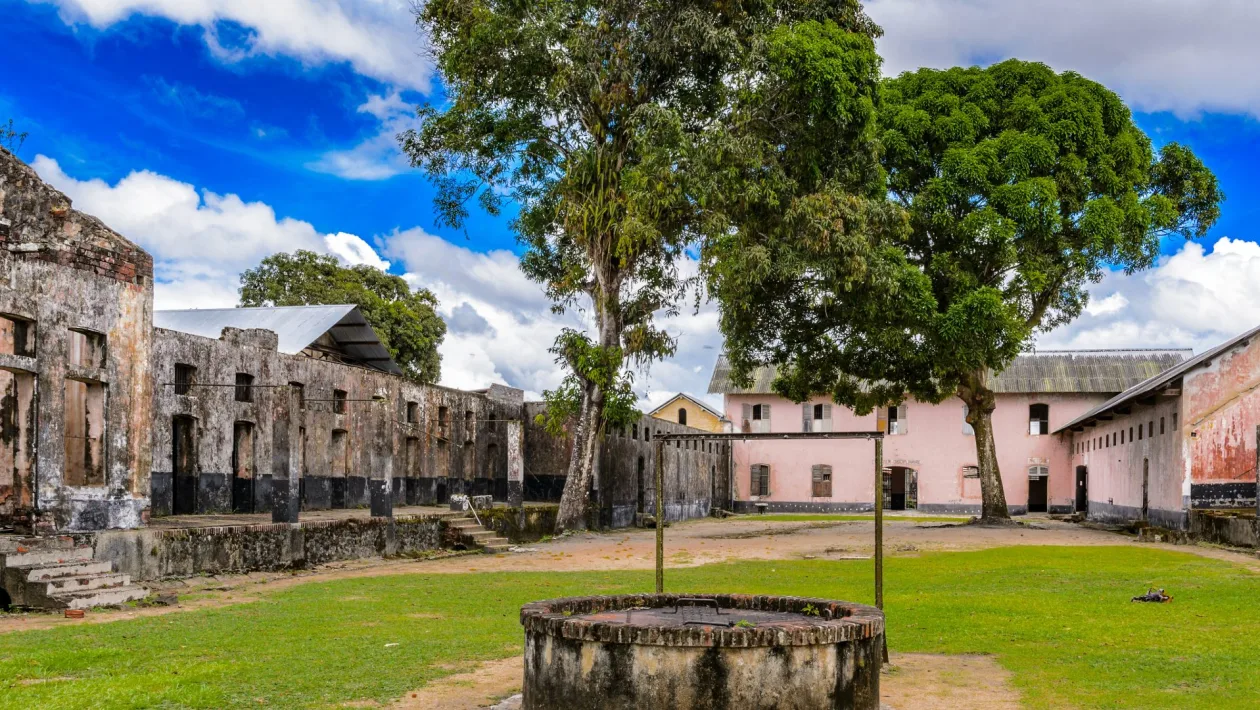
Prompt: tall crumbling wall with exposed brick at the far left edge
<box><xmin>0</xmin><ymin>149</ymin><xmax>152</xmax><ymax>531</ymax></box>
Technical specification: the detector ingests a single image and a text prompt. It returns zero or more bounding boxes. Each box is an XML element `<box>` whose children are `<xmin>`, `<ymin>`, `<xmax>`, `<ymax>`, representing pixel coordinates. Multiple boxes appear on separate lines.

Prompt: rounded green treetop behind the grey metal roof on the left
<box><xmin>241</xmin><ymin>251</ymin><xmax>446</xmax><ymax>383</ymax></box>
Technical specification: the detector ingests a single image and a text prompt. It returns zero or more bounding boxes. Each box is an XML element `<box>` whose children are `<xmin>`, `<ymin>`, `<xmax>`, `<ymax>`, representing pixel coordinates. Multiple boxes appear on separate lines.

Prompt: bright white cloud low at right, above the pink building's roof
<box><xmin>1038</xmin><ymin>238</ymin><xmax>1260</xmax><ymax>351</ymax></box>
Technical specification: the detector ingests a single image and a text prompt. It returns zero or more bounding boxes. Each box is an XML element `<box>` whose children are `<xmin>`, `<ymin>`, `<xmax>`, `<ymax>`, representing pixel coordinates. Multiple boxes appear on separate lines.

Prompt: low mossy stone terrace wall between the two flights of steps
<box><xmin>95</xmin><ymin>516</ymin><xmax>450</xmax><ymax>580</ymax></box>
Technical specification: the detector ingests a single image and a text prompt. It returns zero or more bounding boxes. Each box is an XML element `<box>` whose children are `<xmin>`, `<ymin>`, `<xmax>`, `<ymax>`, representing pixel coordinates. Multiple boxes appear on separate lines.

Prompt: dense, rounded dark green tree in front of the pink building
<box><xmin>711</xmin><ymin>59</ymin><xmax>1222</xmax><ymax>520</ymax></box>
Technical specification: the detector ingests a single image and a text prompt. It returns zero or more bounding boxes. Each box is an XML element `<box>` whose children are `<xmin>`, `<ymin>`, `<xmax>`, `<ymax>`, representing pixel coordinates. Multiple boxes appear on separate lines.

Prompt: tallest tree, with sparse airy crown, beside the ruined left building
<box><xmin>401</xmin><ymin>0</ymin><xmax>878</xmax><ymax>530</ymax></box>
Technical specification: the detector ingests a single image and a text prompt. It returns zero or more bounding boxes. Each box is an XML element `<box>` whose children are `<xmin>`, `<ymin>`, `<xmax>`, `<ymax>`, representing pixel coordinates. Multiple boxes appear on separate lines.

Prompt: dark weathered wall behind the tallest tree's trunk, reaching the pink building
<box><xmin>525</xmin><ymin>402</ymin><xmax>731</xmax><ymax>527</ymax></box>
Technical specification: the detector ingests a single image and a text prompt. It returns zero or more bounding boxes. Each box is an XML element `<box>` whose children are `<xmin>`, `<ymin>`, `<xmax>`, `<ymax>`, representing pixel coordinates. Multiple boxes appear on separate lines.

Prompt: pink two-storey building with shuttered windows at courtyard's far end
<box><xmin>709</xmin><ymin>349</ymin><xmax>1189</xmax><ymax>516</ymax></box>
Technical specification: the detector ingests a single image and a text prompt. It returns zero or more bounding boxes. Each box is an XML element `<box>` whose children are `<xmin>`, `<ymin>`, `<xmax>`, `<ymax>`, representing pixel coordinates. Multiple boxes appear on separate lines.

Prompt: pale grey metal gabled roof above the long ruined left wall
<box><xmin>154</xmin><ymin>304</ymin><xmax>402</xmax><ymax>375</ymax></box>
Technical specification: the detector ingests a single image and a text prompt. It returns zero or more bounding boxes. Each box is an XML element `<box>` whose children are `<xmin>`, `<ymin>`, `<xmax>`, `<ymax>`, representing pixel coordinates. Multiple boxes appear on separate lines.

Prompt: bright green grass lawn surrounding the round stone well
<box><xmin>0</xmin><ymin>547</ymin><xmax>1260</xmax><ymax>710</ymax></box>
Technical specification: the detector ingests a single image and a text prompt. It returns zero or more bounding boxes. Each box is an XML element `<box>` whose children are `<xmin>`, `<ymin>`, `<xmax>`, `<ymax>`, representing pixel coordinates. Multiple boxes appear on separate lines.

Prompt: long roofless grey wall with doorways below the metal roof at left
<box><xmin>152</xmin><ymin>328</ymin><xmax>520</xmax><ymax>515</ymax></box>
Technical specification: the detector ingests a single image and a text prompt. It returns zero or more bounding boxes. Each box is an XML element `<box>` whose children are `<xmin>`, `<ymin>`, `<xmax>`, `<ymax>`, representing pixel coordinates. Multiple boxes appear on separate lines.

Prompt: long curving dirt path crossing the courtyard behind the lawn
<box><xmin>0</xmin><ymin>517</ymin><xmax>1260</xmax><ymax>633</ymax></box>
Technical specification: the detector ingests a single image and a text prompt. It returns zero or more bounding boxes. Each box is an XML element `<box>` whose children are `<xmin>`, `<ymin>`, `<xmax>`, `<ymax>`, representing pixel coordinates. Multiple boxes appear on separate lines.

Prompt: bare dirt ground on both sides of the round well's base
<box><xmin>378</xmin><ymin>653</ymin><xmax>1019</xmax><ymax>710</ymax></box>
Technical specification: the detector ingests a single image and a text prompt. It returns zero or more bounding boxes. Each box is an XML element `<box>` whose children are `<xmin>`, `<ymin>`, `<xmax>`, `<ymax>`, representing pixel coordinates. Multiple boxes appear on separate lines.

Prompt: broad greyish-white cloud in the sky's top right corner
<box><xmin>867</xmin><ymin>0</ymin><xmax>1260</xmax><ymax>116</ymax></box>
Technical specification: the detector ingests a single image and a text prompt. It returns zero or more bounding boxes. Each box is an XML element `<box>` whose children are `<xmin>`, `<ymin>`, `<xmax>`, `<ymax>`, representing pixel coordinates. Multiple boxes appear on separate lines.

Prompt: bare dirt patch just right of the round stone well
<box><xmin>879</xmin><ymin>653</ymin><xmax>1019</xmax><ymax>710</ymax></box>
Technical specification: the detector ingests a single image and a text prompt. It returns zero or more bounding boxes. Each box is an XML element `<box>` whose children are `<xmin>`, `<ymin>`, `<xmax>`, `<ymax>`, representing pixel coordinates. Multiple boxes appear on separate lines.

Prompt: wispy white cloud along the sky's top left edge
<box><xmin>30</xmin><ymin>0</ymin><xmax>433</xmax><ymax>92</ymax></box>
